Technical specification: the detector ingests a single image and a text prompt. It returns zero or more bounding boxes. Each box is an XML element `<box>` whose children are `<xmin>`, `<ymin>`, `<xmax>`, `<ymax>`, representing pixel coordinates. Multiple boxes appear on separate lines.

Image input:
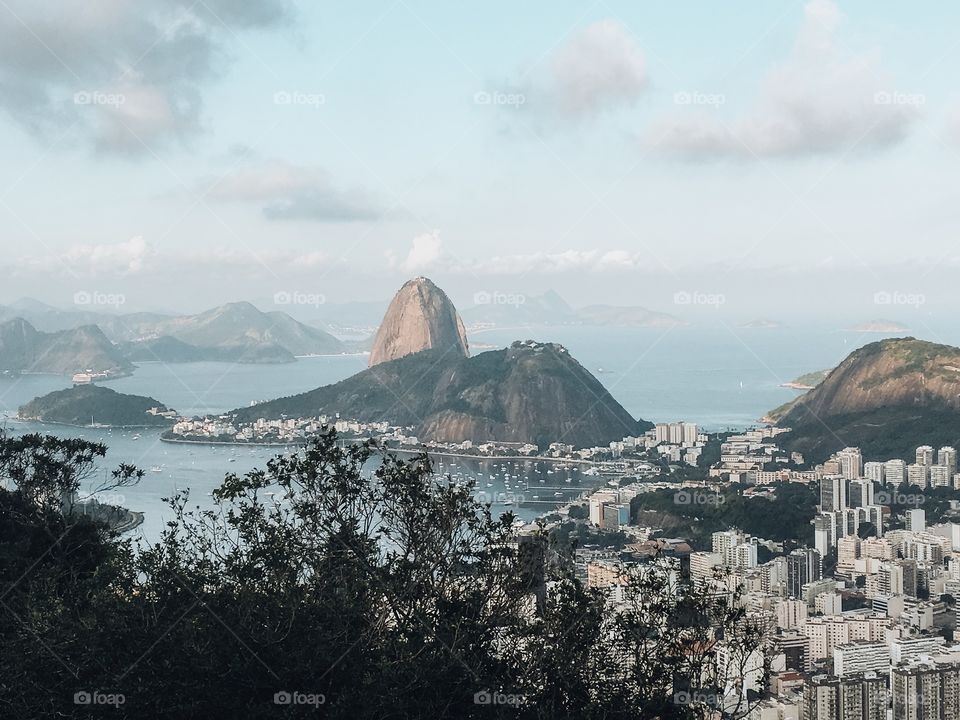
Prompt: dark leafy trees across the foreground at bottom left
<box><xmin>0</xmin><ymin>433</ymin><xmax>759</xmax><ymax>718</ymax></box>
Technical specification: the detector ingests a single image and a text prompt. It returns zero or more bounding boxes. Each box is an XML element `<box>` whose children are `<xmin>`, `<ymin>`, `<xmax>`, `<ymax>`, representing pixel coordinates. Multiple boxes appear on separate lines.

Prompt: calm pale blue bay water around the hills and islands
<box><xmin>0</xmin><ymin>326</ymin><xmax>928</xmax><ymax>539</ymax></box>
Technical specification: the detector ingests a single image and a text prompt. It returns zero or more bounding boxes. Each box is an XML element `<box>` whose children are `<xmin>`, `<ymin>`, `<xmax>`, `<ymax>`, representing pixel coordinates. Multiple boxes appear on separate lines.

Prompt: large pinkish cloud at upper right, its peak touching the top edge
<box><xmin>645</xmin><ymin>0</ymin><xmax>923</xmax><ymax>159</ymax></box>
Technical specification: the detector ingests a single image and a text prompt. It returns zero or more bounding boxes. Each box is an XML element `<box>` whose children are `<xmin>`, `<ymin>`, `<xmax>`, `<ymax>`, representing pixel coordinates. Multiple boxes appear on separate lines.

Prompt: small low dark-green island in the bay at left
<box><xmin>17</xmin><ymin>384</ymin><xmax>177</xmax><ymax>427</ymax></box>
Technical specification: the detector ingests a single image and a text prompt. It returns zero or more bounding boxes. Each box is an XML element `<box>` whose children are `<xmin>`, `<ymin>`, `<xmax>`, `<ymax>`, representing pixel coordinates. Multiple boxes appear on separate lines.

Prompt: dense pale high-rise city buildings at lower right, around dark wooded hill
<box><xmin>564</xmin><ymin>428</ymin><xmax>960</xmax><ymax>720</ymax></box>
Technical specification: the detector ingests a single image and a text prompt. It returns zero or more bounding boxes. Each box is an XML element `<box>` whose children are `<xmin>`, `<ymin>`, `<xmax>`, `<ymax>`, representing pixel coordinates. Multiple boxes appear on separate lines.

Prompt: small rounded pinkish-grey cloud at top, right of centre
<box><xmin>517</xmin><ymin>20</ymin><xmax>648</xmax><ymax>120</ymax></box>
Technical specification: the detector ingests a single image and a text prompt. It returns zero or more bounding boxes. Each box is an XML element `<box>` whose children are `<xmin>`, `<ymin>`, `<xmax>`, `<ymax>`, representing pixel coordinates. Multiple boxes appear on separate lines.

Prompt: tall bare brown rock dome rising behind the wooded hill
<box><xmin>369</xmin><ymin>277</ymin><xmax>470</xmax><ymax>367</ymax></box>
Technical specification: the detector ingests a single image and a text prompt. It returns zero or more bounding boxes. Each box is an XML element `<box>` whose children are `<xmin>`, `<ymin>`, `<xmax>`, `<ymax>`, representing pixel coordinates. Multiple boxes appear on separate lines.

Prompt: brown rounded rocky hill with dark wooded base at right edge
<box><xmin>769</xmin><ymin>338</ymin><xmax>960</xmax><ymax>460</ymax></box>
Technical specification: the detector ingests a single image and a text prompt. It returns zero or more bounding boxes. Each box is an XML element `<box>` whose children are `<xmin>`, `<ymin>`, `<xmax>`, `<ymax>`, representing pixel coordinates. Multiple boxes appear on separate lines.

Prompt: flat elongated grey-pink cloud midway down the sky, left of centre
<box><xmin>207</xmin><ymin>160</ymin><xmax>390</xmax><ymax>222</ymax></box>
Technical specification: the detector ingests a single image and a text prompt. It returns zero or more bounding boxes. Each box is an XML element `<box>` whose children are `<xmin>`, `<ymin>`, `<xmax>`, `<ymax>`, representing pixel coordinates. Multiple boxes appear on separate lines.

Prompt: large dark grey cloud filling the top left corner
<box><xmin>0</xmin><ymin>0</ymin><xmax>291</xmax><ymax>153</ymax></box>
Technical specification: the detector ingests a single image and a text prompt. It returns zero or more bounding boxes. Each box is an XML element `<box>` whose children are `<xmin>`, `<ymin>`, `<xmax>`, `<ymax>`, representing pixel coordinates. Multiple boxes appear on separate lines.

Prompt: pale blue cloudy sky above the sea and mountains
<box><xmin>0</xmin><ymin>0</ymin><xmax>960</xmax><ymax>319</ymax></box>
